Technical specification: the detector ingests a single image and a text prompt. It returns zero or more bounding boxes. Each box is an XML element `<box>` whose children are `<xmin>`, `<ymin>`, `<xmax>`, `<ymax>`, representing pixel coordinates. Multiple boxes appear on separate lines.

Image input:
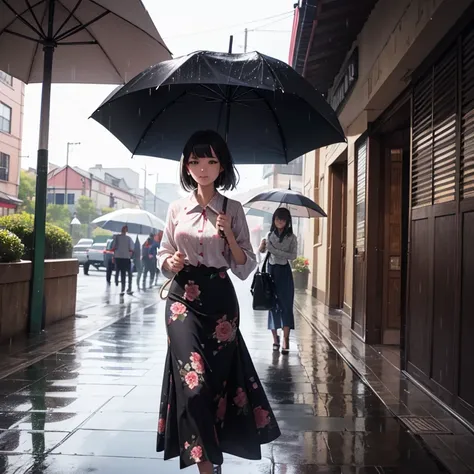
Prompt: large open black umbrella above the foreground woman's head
<box><xmin>92</xmin><ymin>51</ymin><xmax>345</xmax><ymax>164</ymax></box>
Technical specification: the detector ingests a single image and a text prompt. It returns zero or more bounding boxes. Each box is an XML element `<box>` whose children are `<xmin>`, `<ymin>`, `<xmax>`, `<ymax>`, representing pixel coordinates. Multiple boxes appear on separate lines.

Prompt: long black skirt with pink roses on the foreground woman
<box><xmin>157</xmin><ymin>266</ymin><xmax>280</xmax><ymax>469</ymax></box>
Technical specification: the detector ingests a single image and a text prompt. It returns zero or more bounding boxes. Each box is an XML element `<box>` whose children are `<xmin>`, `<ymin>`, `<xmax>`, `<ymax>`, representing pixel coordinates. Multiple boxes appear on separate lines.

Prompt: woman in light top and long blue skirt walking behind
<box><xmin>260</xmin><ymin>207</ymin><xmax>298</xmax><ymax>355</ymax></box>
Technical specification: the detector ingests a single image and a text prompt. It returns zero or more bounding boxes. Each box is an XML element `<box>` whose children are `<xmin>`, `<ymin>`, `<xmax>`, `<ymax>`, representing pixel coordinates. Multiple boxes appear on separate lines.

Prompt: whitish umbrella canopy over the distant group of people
<box><xmin>92</xmin><ymin>209</ymin><xmax>165</xmax><ymax>234</ymax></box>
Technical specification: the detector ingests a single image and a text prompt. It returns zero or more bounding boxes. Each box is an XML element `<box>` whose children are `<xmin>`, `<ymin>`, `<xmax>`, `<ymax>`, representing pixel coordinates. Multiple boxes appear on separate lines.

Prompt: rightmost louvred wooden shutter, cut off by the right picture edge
<box><xmin>461</xmin><ymin>30</ymin><xmax>474</xmax><ymax>199</ymax></box>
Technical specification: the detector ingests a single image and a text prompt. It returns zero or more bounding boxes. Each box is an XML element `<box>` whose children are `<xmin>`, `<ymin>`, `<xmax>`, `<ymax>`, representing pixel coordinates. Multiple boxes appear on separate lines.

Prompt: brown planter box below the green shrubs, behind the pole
<box><xmin>0</xmin><ymin>259</ymin><xmax>79</xmax><ymax>341</ymax></box>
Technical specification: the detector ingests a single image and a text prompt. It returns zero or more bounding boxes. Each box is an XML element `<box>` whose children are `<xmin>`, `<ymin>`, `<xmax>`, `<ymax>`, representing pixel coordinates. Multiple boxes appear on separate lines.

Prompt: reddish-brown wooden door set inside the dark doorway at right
<box><xmin>382</xmin><ymin>148</ymin><xmax>403</xmax><ymax>345</ymax></box>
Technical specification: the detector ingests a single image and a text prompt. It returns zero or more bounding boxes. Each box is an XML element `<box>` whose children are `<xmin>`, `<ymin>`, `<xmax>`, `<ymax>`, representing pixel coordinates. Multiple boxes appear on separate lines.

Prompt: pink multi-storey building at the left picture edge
<box><xmin>0</xmin><ymin>71</ymin><xmax>25</xmax><ymax>216</ymax></box>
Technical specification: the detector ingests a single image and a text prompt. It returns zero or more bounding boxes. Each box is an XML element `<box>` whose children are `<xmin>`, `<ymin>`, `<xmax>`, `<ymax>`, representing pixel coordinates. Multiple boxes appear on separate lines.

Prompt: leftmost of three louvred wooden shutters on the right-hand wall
<box><xmin>411</xmin><ymin>71</ymin><xmax>433</xmax><ymax>207</ymax></box>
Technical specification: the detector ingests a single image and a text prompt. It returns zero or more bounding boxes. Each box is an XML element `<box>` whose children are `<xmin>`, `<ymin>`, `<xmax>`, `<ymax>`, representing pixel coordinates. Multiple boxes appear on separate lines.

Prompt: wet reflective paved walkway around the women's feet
<box><xmin>0</xmin><ymin>275</ymin><xmax>456</xmax><ymax>474</ymax></box>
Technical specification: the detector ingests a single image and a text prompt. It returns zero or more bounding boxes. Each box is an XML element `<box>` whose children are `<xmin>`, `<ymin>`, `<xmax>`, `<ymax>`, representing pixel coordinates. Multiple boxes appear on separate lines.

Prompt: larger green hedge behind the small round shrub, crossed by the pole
<box><xmin>0</xmin><ymin>213</ymin><xmax>72</xmax><ymax>260</ymax></box>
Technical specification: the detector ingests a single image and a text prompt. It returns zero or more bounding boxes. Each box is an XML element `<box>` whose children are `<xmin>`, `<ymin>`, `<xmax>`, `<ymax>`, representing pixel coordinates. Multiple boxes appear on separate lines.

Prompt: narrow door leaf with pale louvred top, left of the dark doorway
<box><xmin>352</xmin><ymin>138</ymin><xmax>368</xmax><ymax>339</ymax></box>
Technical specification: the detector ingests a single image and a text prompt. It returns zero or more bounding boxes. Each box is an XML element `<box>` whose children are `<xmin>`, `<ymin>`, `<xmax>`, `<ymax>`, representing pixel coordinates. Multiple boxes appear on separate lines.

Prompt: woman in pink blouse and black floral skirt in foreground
<box><xmin>157</xmin><ymin>131</ymin><xmax>280</xmax><ymax>474</ymax></box>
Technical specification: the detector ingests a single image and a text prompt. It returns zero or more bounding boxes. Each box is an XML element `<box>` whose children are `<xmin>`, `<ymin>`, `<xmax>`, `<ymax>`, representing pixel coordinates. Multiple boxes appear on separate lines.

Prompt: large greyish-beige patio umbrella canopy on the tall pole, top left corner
<box><xmin>0</xmin><ymin>0</ymin><xmax>171</xmax><ymax>84</ymax></box>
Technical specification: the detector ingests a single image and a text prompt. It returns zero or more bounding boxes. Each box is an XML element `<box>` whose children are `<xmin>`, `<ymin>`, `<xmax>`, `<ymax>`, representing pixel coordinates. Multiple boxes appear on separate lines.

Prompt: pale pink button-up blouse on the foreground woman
<box><xmin>158</xmin><ymin>193</ymin><xmax>257</xmax><ymax>280</ymax></box>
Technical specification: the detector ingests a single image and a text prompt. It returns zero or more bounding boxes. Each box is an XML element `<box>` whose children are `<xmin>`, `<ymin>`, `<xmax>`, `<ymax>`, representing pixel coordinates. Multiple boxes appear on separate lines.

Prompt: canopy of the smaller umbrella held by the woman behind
<box><xmin>244</xmin><ymin>189</ymin><xmax>327</xmax><ymax>218</ymax></box>
